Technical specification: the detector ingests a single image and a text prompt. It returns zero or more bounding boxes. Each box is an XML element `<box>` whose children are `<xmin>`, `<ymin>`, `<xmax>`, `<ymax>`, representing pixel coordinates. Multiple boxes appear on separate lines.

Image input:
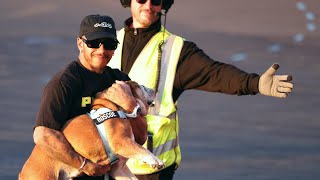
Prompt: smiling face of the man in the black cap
<box><xmin>77</xmin><ymin>36</ymin><xmax>114</xmax><ymax>73</ymax></box>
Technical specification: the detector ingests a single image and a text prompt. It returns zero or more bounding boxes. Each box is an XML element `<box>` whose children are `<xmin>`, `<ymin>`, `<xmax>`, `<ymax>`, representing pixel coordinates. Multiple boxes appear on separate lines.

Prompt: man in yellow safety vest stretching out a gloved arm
<box><xmin>108</xmin><ymin>0</ymin><xmax>293</xmax><ymax>180</ymax></box>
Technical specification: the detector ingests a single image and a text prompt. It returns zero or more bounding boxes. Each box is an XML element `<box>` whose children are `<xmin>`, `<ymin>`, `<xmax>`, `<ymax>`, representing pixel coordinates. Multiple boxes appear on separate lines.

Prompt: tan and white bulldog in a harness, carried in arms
<box><xmin>19</xmin><ymin>81</ymin><xmax>164</xmax><ymax>180</ymax></box>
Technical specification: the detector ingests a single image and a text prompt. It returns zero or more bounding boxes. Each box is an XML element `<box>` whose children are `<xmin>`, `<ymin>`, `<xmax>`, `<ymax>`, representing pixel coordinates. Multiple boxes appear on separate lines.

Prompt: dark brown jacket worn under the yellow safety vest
<box><xmin>121</xmin><ymin>18</ymin><xmax>260</xmax><ymax>101</ymax></box>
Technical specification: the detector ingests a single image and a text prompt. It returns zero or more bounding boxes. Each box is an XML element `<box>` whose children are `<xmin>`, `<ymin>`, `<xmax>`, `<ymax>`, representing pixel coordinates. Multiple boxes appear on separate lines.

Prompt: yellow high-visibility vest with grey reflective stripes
<box><xmin>108</xmin><ymin>27</ymin><xmax>184</xmax><ymax>174</ymax></box>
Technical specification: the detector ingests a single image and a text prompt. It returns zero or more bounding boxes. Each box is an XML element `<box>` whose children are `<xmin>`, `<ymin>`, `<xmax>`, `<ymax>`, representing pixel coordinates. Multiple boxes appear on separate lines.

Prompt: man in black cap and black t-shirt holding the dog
<box><xmin>33</xmin><ymin>15</ymin><xmax>136</xmax><ymax>179</ymax></box>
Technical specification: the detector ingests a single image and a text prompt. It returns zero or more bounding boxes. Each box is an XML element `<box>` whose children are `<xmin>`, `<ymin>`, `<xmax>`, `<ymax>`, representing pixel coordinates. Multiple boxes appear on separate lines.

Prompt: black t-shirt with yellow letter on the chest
<box><xmin>35</xmin><ymin>61</ymin><xmax>130</xmax><ymax>130</ymax></box>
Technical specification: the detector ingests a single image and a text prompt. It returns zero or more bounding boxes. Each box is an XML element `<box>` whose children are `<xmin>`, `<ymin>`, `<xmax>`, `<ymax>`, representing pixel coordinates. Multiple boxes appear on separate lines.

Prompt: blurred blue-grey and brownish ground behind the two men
<box><xmin>0</xmin><ymin>0</ymin><xmax>320</xmax><ymax>180</ymax></box>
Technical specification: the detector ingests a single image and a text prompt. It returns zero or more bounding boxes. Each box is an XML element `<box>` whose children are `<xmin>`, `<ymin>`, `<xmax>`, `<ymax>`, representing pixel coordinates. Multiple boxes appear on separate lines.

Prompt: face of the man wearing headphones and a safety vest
<box><xmin>131</xmin><ymin>0</ymin><xmax>161</xmax><ymax>28</ymax></box>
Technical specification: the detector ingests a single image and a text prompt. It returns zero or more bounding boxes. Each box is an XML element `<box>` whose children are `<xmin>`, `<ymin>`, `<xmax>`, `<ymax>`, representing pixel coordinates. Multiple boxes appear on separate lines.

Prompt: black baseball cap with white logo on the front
<box><xmin>79</xmin><ymin>14</ymin><xmax>118</xmax><ymax>42</ymax></box>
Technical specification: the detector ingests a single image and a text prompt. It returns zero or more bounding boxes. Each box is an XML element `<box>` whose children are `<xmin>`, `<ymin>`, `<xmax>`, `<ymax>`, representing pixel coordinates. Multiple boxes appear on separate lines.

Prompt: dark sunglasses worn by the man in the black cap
<box><xmin>80</xmin><ymin>38</ymin><xmax>118</xmax><ymax>50</ymax></box>
